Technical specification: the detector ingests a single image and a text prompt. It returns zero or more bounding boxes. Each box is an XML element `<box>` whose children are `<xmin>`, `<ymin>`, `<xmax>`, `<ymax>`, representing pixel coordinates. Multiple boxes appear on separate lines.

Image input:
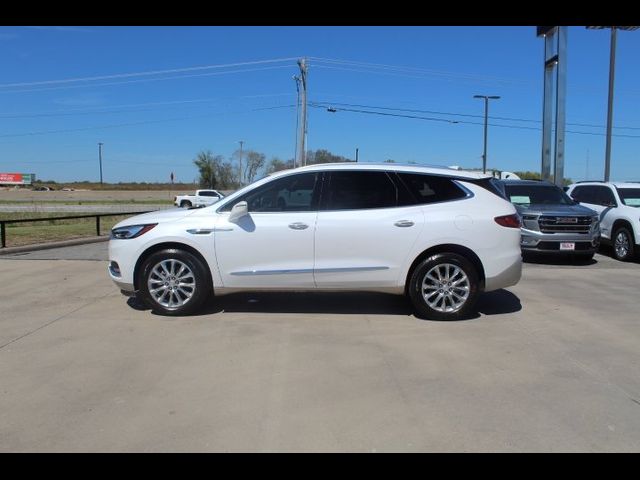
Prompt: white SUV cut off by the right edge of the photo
<box><xmin>567</xmin><ymin>182</ymin><xmax>640</xmax><ymax>261</ymax></box>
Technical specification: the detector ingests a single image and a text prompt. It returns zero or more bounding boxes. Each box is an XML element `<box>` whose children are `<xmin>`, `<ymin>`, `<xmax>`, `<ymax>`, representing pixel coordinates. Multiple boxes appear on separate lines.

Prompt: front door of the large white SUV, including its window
<box><xmin>214</xmin><ymin>172</ymin><xmax>320</xmax><ymax>289</ymax></box>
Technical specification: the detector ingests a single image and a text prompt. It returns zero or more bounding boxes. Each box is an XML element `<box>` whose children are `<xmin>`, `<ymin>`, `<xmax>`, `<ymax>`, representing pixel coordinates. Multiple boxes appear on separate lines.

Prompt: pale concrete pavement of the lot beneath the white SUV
<box><xmin>0</xmin><ymin>244</ymin><xmax>640</xmax><ymax>452</ymax></box>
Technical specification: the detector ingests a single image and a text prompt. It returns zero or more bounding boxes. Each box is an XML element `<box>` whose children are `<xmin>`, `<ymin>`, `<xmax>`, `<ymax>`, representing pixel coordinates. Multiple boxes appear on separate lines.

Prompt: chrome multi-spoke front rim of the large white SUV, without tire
<box><xmin>147</xmin><ymin>259</ymin><xmax>196</xmax><ymax>308</ymax></box>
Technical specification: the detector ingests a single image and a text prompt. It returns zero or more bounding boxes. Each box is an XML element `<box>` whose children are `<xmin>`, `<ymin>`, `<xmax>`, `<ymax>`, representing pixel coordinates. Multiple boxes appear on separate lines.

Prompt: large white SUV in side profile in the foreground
<box><xmin>108</xmin><ymin>163</ymin><xmax>522</xmax><ymax>319</ymax></box>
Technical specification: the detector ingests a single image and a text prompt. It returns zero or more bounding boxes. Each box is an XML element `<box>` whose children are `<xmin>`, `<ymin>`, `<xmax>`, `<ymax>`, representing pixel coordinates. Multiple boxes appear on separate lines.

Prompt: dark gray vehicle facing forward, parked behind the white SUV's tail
<box><xmin>500</xmin><ymin>180</ymin><xmax>600</xmax><ymax>259</ymax></box>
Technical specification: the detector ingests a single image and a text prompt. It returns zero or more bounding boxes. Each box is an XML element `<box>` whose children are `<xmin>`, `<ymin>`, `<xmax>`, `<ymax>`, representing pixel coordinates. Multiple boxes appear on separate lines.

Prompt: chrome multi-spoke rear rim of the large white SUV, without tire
<box><xmin>422</xmin><ymin>263</ymin><xmax>470</xmax><ymax>313</ymax></box>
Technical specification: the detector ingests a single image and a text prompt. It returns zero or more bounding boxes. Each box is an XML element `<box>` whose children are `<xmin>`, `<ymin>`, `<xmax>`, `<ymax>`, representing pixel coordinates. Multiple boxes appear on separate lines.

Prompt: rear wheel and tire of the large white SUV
<box><xmin>407</xmin><ymin>253</ymin><xmax>480</xmax><ymax>320</ymax></box>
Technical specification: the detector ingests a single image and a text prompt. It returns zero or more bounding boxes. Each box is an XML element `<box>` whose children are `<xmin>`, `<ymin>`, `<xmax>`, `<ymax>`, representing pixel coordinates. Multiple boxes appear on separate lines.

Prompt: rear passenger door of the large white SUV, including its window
<box><xmin>314</xmin><ymin>170</ymin><xmax>424</xmax><ymax>288</ymax></box>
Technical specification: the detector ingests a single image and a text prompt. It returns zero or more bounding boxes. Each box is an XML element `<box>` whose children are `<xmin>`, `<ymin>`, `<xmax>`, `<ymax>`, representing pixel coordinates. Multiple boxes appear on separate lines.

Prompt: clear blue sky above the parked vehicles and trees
<box><xmin>0</xmin><ymin>26</ymin><xmax>640</xmax><ymax>182</ymax></box>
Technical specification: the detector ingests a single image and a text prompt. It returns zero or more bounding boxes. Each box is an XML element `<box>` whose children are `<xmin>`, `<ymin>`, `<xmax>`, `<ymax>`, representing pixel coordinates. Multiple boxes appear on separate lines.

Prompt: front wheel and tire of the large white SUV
<box><xmin>138</xmin><ymin>248</ymin><xmax>213</xmax><ymax>316</ymax></box>
